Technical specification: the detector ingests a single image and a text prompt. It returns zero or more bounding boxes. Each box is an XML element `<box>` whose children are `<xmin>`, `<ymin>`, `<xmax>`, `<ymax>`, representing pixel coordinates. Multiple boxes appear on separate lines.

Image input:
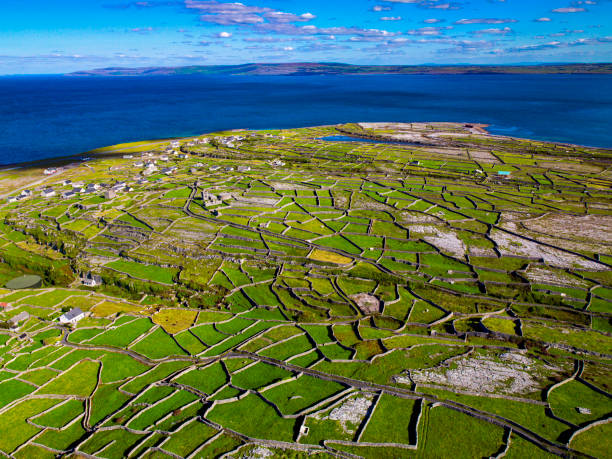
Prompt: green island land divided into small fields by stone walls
<box><xmin>0</xmin><ymin>123</ymin><xmax>612</xmax><ymax>459</ymax></box>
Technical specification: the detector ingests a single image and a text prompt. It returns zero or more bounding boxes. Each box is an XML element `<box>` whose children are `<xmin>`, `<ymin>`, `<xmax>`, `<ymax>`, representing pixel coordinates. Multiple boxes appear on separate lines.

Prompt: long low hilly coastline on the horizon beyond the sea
<box><xmin>68</xmin><ymin>62</ymin><xmax>612</xmax><ymax>77</ymax></box>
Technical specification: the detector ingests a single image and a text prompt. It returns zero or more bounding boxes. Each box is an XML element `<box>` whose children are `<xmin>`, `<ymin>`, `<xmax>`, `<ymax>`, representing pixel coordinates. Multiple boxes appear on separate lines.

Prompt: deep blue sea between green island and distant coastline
<box><xmin>0</xmin><ymin>75</ymin><xmax>612</xmax><ymax>164</ymax></box>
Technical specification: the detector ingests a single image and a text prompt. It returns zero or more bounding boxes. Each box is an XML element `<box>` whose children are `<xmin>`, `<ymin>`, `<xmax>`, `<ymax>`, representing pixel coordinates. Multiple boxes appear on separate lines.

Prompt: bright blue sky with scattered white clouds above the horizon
<box><xmin>0</xmin><ymin>0</ymin><xmax>612</xmax><ymax>74</ymax></box>
